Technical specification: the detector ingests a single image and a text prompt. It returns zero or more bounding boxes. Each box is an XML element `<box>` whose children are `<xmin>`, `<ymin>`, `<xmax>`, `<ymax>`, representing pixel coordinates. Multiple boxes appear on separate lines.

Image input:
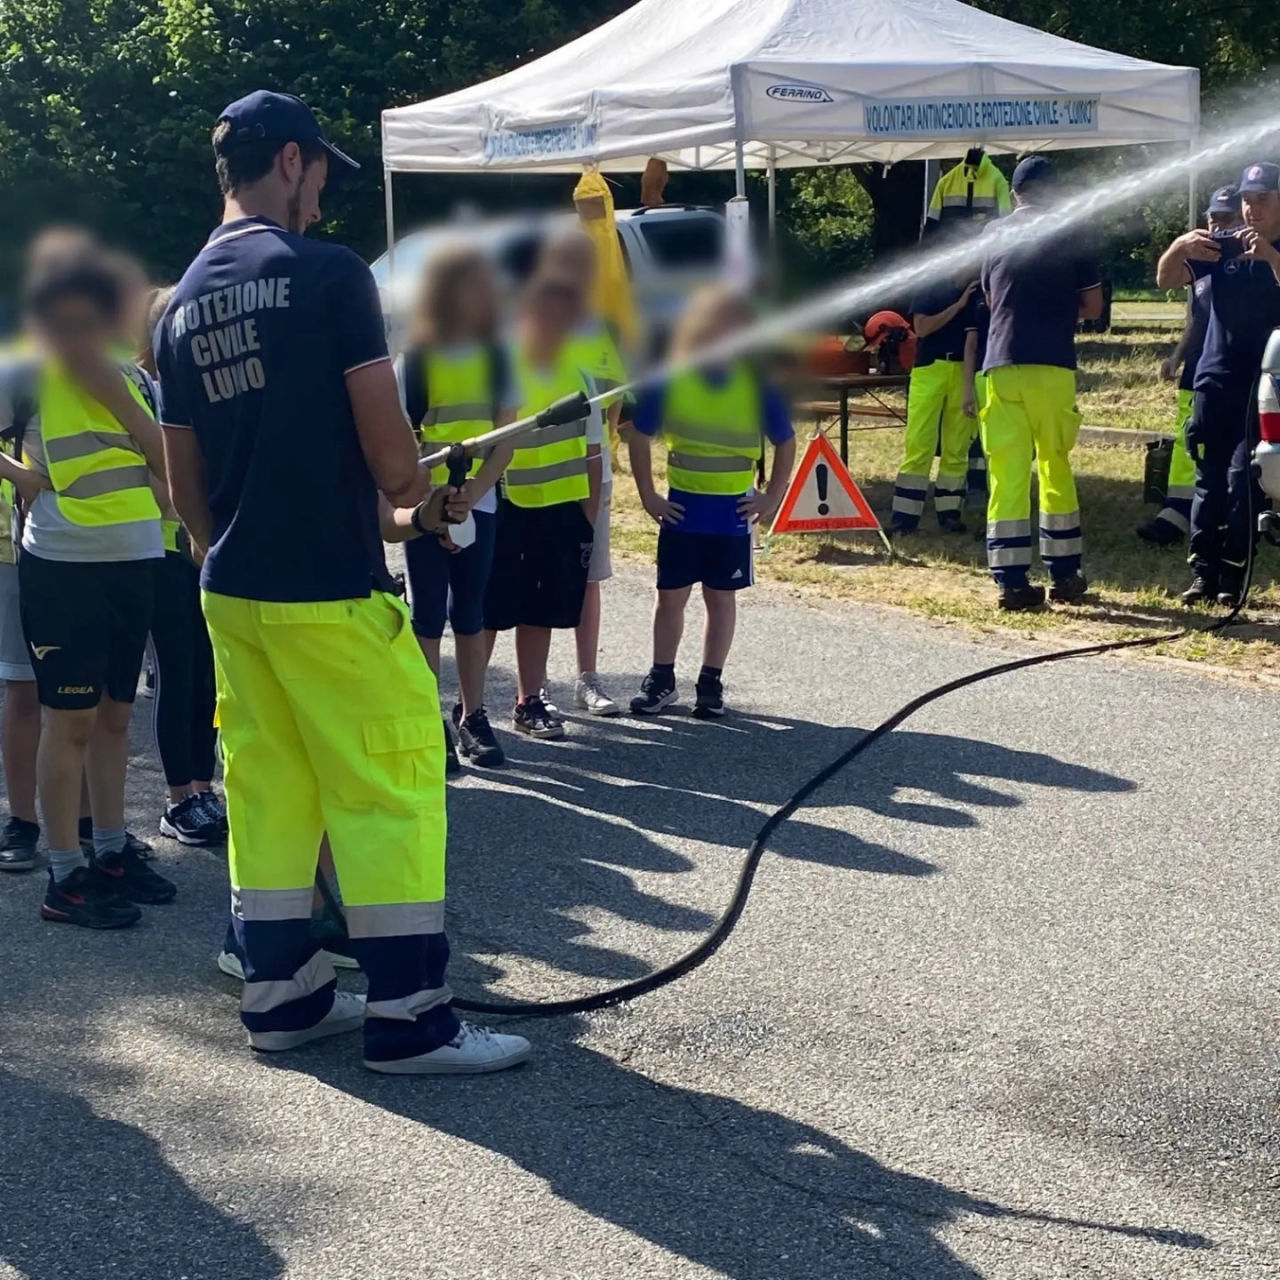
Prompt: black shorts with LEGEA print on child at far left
<box><xmin>18</xmin><ymin>552</ymin><xmax>159</xmax><ymax>709</ymax></box>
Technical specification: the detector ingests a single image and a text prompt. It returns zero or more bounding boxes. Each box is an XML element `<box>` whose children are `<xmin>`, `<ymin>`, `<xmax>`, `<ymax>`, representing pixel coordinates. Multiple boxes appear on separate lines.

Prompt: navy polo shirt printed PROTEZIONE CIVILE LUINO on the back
<box><xmin>155</xmin><ymin>218</ymin><xmax>390</xmax><ymax>602</ymax></box>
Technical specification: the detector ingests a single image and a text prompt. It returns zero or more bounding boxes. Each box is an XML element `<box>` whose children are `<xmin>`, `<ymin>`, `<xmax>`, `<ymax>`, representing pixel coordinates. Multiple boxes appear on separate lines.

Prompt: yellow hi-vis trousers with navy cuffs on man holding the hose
<box><xmin>204</xmin><ymin>591</ymin><xmax>457</xmax><ymax>1059</ymax></box>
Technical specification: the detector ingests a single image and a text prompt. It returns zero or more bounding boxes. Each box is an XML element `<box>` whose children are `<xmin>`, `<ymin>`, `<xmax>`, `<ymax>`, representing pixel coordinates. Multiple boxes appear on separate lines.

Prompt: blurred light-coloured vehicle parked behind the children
<box><xmin>371</xmin><ymin>205</ymin><xmax>724</xmax><ymax>352</ymax></box>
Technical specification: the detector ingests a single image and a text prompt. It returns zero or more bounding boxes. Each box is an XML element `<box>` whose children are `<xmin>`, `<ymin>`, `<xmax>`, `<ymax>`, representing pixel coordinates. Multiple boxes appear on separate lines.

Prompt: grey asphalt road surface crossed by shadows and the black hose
<box><xmin>0</xmin><ymin>573</ymin><xmax>1280</xmax><ymax>1280</ymax></box>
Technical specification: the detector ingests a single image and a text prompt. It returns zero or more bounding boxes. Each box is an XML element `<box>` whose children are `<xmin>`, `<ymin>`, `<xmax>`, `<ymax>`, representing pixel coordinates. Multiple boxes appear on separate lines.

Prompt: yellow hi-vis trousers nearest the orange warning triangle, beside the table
<box><xmin>893</xmin><ymin>360</ymin><xmax>978</xmax><ymax>529</ymax></box>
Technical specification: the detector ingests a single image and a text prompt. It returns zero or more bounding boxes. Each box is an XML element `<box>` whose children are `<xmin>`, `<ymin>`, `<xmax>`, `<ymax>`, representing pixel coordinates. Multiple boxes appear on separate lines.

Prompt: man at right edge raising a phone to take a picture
<box><xmin>1156</xmin><ymin>161</ymin><xmax>1280</xmax><ymax>608</ymax></box>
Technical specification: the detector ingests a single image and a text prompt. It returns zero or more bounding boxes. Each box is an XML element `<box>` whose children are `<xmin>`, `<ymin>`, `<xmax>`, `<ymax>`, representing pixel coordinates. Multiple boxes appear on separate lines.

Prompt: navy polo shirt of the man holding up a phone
<box><xmin>1187</xmin><ymin>243</ymin><xmax>1280</xmax><ymax>396</ymax></box>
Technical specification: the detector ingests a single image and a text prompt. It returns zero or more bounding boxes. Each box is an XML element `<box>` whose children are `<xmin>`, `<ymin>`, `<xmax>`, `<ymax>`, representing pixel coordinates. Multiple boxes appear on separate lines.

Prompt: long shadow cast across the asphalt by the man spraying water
<box><xmin>278</xmin><ymin>1024</ymin><xmax>1213</xmax><ymax>1280</ymax></box>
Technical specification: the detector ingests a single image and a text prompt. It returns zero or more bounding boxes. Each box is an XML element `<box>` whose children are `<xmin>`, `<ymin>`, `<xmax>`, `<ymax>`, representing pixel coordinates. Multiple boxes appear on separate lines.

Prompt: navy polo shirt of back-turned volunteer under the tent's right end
<box><xmin>982</xmin><ymin>209</ymin><xmax>1102</xmax><ymax>371</ymax></box>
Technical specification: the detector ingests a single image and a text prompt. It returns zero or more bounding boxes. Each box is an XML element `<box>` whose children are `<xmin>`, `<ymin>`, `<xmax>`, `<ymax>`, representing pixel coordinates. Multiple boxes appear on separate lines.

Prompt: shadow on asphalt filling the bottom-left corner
<box><xmin>0</xmin><ymin>1068</ymin><xmax>284</xmax><ymax>1280</ymax></box>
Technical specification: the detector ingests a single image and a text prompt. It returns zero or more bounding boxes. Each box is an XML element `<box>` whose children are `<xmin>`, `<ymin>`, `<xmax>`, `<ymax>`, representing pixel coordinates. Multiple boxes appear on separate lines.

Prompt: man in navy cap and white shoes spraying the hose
<box><xmin>155</xmin><ymin>90</ymin><xmax>529</xmax><ymax>1075</ymax></box>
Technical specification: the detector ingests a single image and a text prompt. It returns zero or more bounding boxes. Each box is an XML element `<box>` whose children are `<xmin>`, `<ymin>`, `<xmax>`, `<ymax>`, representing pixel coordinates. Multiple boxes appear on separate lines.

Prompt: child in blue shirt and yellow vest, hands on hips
<box><xmin>628</xmin><ymin>285</ymin><xmax>796</xmax><ymax>719</ymax></box>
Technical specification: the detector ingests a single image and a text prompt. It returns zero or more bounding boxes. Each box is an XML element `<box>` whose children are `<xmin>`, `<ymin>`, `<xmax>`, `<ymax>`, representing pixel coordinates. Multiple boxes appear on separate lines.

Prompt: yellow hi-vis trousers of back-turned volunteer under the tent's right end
<box><xmin>980</xmin><ymin>365</ymin><xmax>1080</xmax><ymax>585</ymax></box>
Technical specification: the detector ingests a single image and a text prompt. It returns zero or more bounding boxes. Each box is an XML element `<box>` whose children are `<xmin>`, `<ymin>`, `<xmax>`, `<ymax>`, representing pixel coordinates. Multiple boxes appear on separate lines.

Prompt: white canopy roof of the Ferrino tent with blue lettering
<box><xmin>383</xmin><ymin>0</ymin><xmax>1199</xmax><ymax>247</ymax></box>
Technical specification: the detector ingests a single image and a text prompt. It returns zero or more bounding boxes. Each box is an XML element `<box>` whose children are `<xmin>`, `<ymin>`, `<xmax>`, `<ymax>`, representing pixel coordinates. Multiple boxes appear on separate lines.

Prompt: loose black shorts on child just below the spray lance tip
<box><xmin>484</xmin><ymin>498</ymin><xmax>595</xmax><ymax>631</ymax></box>
